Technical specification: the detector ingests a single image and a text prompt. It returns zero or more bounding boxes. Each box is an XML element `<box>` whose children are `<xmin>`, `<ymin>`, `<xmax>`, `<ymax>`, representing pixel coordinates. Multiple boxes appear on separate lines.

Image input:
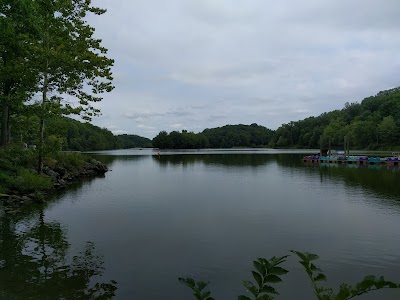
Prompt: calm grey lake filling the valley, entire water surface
<box><xmin>0</xmin><ymin>149</ymin><xmax>400</xmax><ymax>300</ymax></box>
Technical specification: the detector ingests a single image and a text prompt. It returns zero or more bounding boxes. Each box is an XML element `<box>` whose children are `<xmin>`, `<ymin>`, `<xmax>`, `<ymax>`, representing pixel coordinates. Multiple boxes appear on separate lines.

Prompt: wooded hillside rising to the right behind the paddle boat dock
<box><xmin>269</xmin><ymin>87</ymin><xmax>400</xmax><ymax>150</ymax></box>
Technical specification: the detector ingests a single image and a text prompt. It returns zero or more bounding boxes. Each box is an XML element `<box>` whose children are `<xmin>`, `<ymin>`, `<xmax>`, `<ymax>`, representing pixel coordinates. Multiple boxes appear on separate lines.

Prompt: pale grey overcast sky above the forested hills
<box><xmin>89</xmin><ymin>0</ymin><xmax>400</xmax><ymax>138</ymax></box>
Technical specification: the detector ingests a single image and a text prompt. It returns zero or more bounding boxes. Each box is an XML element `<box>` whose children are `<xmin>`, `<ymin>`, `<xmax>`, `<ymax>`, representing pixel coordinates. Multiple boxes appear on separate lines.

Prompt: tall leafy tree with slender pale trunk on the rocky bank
<box><xmin>29</xmin><ymin>0</ymin><xmax>114</xmax><ymax>173</ymax></box>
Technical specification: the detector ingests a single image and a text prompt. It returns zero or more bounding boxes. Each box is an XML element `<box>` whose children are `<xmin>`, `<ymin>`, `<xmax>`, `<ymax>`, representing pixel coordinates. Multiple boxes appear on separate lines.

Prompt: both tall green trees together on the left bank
<box><xmin>0</xmin><ymin>0</ymin><xmax>114</xmax><ymax>173</ymax></box>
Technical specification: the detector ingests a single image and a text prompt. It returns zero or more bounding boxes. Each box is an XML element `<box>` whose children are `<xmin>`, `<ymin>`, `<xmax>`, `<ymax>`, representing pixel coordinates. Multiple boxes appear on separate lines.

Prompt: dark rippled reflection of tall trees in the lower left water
<box><xmin>0</xmin><ymin>211</ymin><xmax>117</xmax><ymax>299</ymax></box>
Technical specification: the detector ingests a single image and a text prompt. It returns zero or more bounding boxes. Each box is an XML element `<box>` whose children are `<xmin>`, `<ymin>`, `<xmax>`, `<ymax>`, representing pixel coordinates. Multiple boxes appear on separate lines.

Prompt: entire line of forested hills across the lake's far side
<box><xmin>47</xmin><ymin>87</ymin><xmax>400</xmax><ymax>151</ymax></box>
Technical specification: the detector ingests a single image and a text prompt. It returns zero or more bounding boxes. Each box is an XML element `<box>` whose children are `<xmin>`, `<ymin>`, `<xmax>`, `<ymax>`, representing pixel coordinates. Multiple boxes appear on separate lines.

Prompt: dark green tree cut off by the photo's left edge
<box><xmin>0</xmin><ymin>0</ymin><xmax>36</xmax><ymax>146</ymax></box>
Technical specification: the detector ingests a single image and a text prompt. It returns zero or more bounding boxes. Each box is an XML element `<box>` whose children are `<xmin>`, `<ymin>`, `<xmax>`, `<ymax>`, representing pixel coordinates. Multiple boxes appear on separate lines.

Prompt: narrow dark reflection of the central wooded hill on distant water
<box><xmin>153</xmin><ymin>154</ymin><xmax>274</xmax><ymax>167</ymax></box>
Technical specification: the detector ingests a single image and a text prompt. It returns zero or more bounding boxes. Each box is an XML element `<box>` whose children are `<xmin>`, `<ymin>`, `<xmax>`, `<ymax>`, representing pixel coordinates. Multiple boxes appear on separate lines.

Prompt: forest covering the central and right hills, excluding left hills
<box><xmin>153</xmin><ymin>87</ymin><xmax>400</xmax><ymax>150</ymax></box>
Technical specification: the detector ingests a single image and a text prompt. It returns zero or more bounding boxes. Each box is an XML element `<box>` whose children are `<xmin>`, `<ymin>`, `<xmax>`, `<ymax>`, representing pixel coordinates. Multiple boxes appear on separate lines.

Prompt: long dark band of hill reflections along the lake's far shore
<box><xmin>95</xmin><ymin>153</ymin><xmax>400</xmax><ymax>203</ymax></box>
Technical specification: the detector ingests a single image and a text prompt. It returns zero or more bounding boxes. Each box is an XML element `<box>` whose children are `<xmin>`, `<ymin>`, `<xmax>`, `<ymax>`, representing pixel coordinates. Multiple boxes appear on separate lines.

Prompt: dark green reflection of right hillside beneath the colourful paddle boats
<box><xmin>277</xmin><ymin>154</ymin><xmax>400</xmax><ymax>204</ymax></box>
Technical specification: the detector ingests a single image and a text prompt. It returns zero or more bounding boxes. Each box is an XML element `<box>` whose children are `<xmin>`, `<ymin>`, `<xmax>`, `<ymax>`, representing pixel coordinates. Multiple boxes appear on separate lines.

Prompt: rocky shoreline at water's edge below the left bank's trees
<box><xmin>0</xmin><ymin>159</ymin><xmax>108</xmax><ymax>217</ymax></box>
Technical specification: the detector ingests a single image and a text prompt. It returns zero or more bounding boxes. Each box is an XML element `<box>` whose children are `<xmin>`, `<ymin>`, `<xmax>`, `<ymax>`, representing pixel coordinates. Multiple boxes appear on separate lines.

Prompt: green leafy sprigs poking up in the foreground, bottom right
<box><xmin>179</xmin><ymin>250</ymin><xmax>400</xmax><ymax>300</ymax></box>
